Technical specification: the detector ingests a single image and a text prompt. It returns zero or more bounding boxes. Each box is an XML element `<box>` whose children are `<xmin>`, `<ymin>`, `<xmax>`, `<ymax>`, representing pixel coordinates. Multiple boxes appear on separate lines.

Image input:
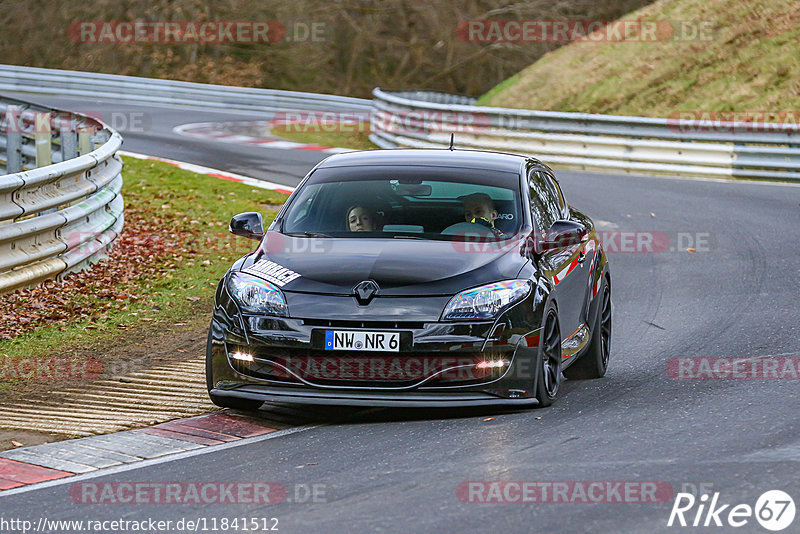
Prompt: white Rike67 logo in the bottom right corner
<box><xmin>667</xmin><ymin>490</ymin><xmax>796</xmax><ymax>532</ymax></box>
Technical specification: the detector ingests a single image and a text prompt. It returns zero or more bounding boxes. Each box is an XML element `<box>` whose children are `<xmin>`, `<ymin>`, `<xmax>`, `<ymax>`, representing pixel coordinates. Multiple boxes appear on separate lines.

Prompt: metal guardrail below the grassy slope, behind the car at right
<box><xmin>370</xmin><ymin>88</ymin><xmax>800</xmax><ymax>180</ymax></box>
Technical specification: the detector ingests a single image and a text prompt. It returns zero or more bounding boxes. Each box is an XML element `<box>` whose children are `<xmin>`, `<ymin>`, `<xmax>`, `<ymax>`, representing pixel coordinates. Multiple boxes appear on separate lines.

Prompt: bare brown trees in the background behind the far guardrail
<box><xmin>0</xmin><ymin>0</ymin><xmax>650</xmax><ymax>96</ymax></box>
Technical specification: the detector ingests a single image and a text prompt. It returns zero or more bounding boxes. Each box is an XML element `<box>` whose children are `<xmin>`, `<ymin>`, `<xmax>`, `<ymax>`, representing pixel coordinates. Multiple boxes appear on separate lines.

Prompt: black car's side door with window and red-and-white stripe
<box><xmin>528</xmin><ymin>169</ymin><xmax>589</xmax><ymax>339</ymax></box>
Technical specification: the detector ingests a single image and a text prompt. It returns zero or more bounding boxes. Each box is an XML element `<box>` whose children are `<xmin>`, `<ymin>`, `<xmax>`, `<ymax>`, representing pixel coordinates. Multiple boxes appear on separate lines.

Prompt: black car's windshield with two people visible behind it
<box><xmin>282</xmin><ymin>167</ymin><xmax>522</xmax><ymax>240</ymax></box>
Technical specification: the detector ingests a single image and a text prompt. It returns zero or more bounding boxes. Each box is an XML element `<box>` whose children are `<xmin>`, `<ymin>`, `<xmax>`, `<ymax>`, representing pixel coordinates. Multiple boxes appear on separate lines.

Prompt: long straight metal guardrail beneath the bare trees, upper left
<box><xmin>0</xmin><ymin>65</ymin><xmax>370</xmax><ymax>112</ymax></box>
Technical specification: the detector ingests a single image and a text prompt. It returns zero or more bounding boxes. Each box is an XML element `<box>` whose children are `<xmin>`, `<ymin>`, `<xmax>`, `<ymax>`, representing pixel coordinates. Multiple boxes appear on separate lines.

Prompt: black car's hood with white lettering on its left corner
<box><xmin>234</xmin><ymin>232</ymin><xmax>527</xmax><ymax>297</ymax></box>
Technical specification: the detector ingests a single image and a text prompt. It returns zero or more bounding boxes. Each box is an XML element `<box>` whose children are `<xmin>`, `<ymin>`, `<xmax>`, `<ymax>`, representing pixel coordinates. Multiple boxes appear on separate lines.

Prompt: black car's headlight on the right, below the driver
<box><xmin>442</xmin><ymin>280</ymin><xmax>531</xmax><ymax>320</ymax></box>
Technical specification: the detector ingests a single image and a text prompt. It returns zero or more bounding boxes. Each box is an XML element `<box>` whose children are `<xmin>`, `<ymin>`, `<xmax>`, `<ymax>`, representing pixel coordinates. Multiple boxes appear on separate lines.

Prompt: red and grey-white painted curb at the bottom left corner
<box><xmin>0</xmin><ymin>412</ymin><xmax>285</xmax><ymax>494</ymax></box>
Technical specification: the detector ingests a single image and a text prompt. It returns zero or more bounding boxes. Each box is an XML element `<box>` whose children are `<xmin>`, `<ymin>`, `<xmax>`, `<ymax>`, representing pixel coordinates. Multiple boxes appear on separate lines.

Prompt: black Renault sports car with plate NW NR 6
<box><xmin>206</xmin><ymin>150</ymin><xmax>611</xmax><ymax>409</ymax></box>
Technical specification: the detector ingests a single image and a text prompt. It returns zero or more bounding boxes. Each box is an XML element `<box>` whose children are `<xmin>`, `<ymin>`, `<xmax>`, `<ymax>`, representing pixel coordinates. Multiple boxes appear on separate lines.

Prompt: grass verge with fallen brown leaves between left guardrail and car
<box><xmin>0</xmin><ymin>158</ymin><xmax>287</xmax><ymax>390</ymax></box>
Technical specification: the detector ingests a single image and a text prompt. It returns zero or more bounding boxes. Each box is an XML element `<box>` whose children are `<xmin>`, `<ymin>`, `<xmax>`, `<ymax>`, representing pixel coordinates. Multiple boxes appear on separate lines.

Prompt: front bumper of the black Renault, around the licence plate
<box><xmin>207</xmin><ymin>296</ymin><xmax>540</xmax><ymax>407</ymax></box>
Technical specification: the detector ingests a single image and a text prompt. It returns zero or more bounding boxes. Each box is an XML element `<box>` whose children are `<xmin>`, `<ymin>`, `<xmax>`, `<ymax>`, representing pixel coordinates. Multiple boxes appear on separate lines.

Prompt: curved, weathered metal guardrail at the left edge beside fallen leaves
<box><xmin>0</xmin><ymin>98</ymin><xmax>124</xmax><ymax>293</ymax></box>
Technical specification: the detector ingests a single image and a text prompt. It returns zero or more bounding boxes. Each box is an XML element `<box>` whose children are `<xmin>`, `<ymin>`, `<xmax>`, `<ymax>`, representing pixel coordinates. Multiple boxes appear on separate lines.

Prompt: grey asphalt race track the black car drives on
<box><xmin>0</xmin><ymin>97</ymin><xmax>800</xmax><ymax>533</ymax></box>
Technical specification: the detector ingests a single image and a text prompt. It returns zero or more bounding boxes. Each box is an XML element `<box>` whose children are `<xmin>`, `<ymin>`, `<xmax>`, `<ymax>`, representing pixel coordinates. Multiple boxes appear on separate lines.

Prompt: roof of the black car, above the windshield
<box><xmin>318</xmin><ymin>148</ymin><xmax>535</xmax><ymax>173</ymax></box>
